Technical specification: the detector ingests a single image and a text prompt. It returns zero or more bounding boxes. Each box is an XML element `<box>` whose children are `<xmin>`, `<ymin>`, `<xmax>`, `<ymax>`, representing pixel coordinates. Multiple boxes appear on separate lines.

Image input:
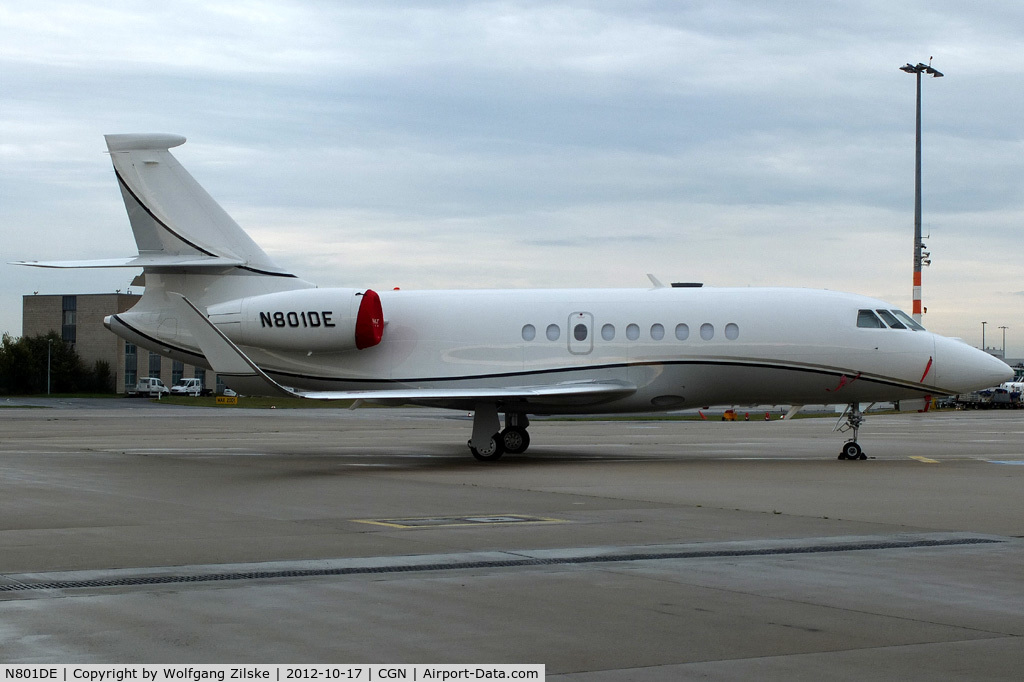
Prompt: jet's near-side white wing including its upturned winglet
<box><xmin>170</xmin><ymin>293</ymin><xmax>636</xmax><ymax>408</ymax></box>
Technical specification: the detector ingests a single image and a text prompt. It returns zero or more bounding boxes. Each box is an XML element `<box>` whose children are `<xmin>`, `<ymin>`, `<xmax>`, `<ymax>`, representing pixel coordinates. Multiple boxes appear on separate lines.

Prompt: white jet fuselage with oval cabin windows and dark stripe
<box><xmin>111</xmin><ymin>280</ymin><xmax>1005</xmax><ymax>413</ymax></box>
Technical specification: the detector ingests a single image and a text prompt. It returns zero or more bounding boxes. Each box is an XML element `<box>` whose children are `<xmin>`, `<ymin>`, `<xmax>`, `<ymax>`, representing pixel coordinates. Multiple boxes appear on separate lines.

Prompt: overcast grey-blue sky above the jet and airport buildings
<box><xmin>0</xmin><ymin>0</ymin><xmax>1024</xmax><ymax>357</ymax></box>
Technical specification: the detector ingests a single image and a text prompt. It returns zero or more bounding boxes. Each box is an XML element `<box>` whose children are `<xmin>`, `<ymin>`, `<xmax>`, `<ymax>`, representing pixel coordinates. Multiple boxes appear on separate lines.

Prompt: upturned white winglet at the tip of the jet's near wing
<box><xmin>168</xmin><ymin>292</ymin><xmax>299</xmax><ymax>397</ymax></box>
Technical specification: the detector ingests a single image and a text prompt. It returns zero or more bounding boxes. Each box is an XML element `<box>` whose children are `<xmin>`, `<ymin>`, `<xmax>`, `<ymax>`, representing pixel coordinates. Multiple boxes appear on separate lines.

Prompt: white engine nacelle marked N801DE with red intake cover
<box><xmin>207</xmin><ymin>289</ymin><xmax>384</xmax><ymax>352</ymax></box>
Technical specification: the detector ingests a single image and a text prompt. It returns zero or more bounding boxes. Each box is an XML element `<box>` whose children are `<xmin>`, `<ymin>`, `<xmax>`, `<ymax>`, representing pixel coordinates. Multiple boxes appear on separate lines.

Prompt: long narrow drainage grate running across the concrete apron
<box><xmin>0</xmin><ymin>538</ymin><xmax>1004</xmax><ymax>592</ymax></box>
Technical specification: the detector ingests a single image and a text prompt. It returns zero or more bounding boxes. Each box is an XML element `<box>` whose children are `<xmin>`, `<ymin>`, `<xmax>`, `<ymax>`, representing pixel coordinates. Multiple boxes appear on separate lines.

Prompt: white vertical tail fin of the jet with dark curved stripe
<box><xmin>105</xmin><ymin>134</ymin><xmax>294</xmax><ymax>276</ymax></box>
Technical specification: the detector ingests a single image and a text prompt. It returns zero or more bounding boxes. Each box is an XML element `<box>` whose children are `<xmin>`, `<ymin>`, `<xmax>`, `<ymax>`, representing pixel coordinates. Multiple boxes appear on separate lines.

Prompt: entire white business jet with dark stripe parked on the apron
<box><xmin>24</xmin><ymin>134</ymin><xmax>1013</xmax><ymax>461</ymax></box>
